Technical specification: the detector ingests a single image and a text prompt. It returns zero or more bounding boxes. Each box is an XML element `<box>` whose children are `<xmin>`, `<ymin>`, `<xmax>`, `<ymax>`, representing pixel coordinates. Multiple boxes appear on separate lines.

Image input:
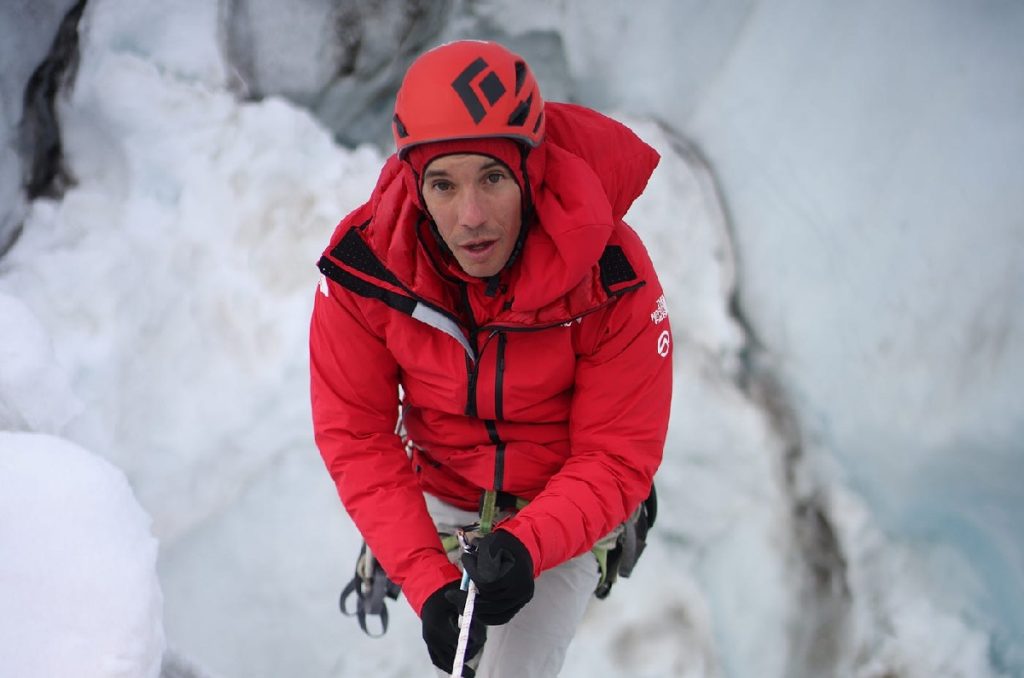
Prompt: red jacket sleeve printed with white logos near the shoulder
<box><xmin>501</xmin><ymin>249</ymin><xmax>672</xmax><ymax>576</ymax></box>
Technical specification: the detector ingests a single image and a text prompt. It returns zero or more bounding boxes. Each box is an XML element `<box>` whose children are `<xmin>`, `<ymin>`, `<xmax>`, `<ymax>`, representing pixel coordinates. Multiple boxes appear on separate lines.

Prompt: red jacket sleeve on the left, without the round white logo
<box><xmin>309</xmin><ymin>278</ymin><xmax>459</xmax><ymax>613</ymax></box>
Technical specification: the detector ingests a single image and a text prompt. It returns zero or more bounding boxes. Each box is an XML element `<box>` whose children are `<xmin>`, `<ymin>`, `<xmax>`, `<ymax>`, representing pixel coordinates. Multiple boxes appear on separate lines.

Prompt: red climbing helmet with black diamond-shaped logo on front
<box><xmin>392</xmin><ymin>40</ymin><xmax>544</xmax><ymax>156</ymax></box>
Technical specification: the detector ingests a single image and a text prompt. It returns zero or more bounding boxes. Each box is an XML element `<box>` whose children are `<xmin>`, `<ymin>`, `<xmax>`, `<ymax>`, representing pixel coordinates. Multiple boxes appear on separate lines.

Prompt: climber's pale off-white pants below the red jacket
<box><xmin>426</xmin><ymin>495</ymin><xmax>600</xmax><ymax>678</ymax></box>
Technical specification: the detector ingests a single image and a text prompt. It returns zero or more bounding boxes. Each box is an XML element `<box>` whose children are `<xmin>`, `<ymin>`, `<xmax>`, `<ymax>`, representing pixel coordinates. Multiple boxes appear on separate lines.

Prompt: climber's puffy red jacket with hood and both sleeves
<box><xmin>309</xmin><ymin>103</ymin><xmax>672</xmax><ymax>612</ymax></box>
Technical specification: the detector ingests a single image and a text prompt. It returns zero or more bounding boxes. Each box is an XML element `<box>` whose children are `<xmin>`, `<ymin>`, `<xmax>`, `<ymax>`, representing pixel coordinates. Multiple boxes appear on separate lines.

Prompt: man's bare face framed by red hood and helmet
<box><xmin>423</xmin><ymin>154</ymin><xmax>522</xmax><ymax>278</ymax></box>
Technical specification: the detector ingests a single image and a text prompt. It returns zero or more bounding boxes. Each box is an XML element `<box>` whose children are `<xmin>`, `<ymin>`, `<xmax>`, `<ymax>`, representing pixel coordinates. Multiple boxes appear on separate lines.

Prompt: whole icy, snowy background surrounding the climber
<box><xmin>0</xmin><ymin>0</ymin><xmax>1024</xmax><ymax>678</ymax></box>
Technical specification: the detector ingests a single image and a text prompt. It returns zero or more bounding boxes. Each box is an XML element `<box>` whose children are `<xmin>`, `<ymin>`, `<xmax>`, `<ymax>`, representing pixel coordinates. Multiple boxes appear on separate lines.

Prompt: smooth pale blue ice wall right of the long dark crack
<box><xmin>685</xmin><ymin>2</ymin><xmax>1024</xmax><ymax>671</ymax></box>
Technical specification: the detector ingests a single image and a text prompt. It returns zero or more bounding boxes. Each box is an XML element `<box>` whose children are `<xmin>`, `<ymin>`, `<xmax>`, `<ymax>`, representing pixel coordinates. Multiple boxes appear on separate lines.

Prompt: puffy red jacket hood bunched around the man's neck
<box><xmin>328</xmin><ymin>102</ymin><xmax>659</xmax><ymax>313</ymax></box>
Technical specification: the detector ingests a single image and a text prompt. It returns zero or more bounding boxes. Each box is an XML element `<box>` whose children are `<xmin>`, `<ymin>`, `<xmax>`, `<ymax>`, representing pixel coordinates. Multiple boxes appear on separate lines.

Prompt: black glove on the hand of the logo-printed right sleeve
<box><xmin>462</xmin><ymin>529</ymin><xmax>534</xmax><ymax>626</ymax></box>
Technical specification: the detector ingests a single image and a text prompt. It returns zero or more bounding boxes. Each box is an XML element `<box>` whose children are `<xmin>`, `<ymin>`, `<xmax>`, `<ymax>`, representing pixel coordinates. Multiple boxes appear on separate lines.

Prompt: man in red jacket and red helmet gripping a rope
<box><xmin>310</xmin><ymin>41</ymin><xmax>672</xmax><ymax>678</ymax></box>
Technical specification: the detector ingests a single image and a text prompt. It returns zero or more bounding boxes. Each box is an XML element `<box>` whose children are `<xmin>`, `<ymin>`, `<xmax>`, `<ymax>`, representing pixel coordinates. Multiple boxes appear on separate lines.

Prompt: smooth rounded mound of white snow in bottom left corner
<box><xmin>0</xmin><ymin>430</ymin><xmax>164</xmax><ymax>678</ymax></box>
